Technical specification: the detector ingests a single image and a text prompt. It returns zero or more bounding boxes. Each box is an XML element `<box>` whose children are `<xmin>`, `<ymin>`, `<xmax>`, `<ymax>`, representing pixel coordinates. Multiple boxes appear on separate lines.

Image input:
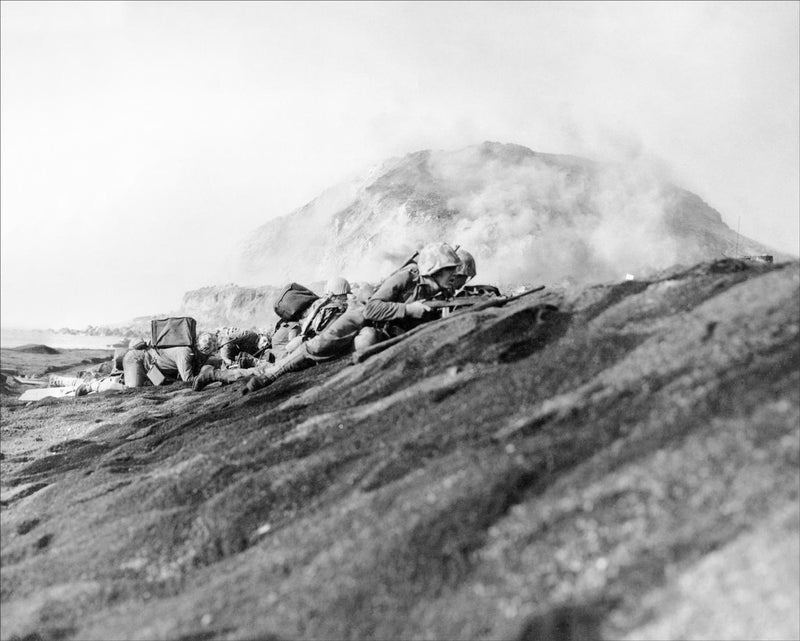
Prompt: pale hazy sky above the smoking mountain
<box><xmin>0</xmin><ymin>0</ymin><xmax>800</xmax><ymax>327</ymax></box>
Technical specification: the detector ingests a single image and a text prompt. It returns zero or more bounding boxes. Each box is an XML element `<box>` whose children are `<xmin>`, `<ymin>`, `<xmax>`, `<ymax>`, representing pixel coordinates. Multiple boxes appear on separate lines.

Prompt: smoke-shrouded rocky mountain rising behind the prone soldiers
<box><xmin>237</xmin><ymin>142</ymin><xmax>773</xmax><ymax>285</ymax></box>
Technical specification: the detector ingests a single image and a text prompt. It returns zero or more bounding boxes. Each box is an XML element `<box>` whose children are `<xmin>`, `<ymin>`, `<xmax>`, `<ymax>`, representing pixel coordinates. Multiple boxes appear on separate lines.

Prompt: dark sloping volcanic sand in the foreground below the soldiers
<box><xmin>0</xmin><ymin>260</ymin><xmax>800</xmax><ymax>640</ymax></box>
